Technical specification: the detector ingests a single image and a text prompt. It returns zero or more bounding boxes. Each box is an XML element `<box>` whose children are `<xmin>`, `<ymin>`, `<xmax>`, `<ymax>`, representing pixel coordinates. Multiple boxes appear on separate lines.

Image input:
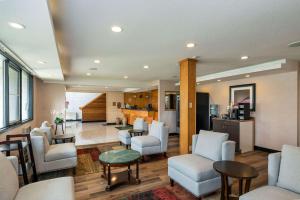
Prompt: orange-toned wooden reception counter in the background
<box><xmin>122</xmin><ymin>108</ymin><xmax>158</xmax><ymax>125</ymax></box>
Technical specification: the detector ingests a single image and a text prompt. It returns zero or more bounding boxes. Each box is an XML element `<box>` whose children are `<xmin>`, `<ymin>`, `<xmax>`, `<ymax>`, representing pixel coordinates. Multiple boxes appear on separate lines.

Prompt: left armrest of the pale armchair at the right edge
<box><xmin>268</xmin><ymin>152</ymin><xmax>281</xmax><ymax>185</ymax></box>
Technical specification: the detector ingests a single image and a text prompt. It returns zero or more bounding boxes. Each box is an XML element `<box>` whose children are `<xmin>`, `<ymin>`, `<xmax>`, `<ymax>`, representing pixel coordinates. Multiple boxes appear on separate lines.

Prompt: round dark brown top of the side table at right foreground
<box><xmin>213</xmin><ymin>160</ymin><xmax>258</xmax><ymax>179</ymax></box>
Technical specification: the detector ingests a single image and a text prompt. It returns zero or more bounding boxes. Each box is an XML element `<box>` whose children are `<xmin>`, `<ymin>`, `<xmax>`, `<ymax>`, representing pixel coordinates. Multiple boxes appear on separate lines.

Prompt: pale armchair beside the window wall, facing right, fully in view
<box><xmin>30</xmin><ymin>128</ymin><xmax>77</xmax><ymax>174</ymax></box>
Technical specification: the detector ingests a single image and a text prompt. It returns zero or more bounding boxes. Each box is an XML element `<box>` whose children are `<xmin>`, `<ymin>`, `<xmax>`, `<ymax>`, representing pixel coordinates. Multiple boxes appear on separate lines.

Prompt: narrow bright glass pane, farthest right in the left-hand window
<box><xmin>22</xmin><ymin>71</ymin><xmax>29</xmax><ymax>120</ymax></box>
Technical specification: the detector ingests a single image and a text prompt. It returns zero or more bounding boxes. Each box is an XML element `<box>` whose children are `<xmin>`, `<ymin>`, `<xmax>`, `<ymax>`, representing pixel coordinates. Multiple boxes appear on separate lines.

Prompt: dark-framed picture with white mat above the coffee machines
<box><xmin>229</xmin><ymin>83</ymin><xmax>256</xmax><ymax>111</ymax></box>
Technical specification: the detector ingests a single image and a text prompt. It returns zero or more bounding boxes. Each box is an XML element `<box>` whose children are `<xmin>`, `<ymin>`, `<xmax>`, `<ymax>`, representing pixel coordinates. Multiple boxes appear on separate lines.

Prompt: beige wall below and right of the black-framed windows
<box><xmin>0</xmin><ymin>78</ymin><xmax>65</xmax><ymax>141</ymax></box>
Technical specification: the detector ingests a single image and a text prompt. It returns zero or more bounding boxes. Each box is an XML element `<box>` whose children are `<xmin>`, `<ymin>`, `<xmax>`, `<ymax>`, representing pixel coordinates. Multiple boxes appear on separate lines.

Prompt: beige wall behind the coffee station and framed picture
<box><xmin>197</xmin><ymin>71</ymin><xmax>298</xmax><ymax>150</ymax></box>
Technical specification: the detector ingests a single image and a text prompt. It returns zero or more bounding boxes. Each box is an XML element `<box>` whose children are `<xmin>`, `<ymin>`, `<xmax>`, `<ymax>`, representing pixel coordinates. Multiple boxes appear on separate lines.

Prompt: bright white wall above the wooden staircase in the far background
<box><xmin>66</xmin><ymin>92</ymin><xmax>100</xmax><ymax>119</ymax></box>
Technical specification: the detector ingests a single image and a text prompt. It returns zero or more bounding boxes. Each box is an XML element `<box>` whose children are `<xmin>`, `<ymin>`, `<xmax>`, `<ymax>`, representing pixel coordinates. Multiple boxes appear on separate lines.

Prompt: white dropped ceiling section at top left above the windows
<box><xmin>0</xmin><ymin>0</ymin><xmax>64</xmax><ymax>80</ymax></box>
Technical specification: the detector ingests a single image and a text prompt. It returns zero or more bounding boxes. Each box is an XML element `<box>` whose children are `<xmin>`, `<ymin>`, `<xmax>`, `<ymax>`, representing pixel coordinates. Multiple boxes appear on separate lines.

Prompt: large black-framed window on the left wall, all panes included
<box><xmin>0</xmin><ymin>51</ymin><xmax>33</xmax><ymax>131</ymax></box>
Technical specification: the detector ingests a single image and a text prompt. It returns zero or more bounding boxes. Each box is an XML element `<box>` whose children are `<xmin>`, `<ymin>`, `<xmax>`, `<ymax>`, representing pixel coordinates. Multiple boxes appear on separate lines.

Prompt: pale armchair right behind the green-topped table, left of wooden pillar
<box><xmin>131</xmin><ymin>121</ymin><xmax>169</xmax><ymax>156</ymax></box>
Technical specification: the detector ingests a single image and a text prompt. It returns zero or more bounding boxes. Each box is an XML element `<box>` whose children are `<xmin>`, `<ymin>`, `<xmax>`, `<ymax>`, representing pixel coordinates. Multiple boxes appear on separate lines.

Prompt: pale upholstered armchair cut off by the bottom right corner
<box><xmin>240</xmin><ymin>145</ymin><xmax>300</xmax><ymax>200</ymax></box>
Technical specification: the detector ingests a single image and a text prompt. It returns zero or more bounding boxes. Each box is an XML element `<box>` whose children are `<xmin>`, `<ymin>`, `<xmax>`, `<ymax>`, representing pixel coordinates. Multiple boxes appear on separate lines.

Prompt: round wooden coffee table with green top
<box><xmin>99</xmin><ymin>149</ymin><xmax>141</xmax><ymax>191</ymax></box>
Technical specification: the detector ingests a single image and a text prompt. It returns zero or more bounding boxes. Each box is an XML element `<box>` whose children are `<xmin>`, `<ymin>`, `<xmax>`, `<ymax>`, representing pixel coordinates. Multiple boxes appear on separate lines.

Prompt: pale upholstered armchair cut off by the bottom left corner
<box><xmin>0</xmin><ymin>153</ymin><xmax>75</xmax><ymax>200</ymax></box>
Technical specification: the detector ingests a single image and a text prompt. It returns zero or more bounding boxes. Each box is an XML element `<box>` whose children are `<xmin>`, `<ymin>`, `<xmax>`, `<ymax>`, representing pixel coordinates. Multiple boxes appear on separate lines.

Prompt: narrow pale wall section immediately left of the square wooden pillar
<box><xmin>158</xmin><ymin>80</ymin><xmax>179</xmax><ymax>133</ymax></box>
